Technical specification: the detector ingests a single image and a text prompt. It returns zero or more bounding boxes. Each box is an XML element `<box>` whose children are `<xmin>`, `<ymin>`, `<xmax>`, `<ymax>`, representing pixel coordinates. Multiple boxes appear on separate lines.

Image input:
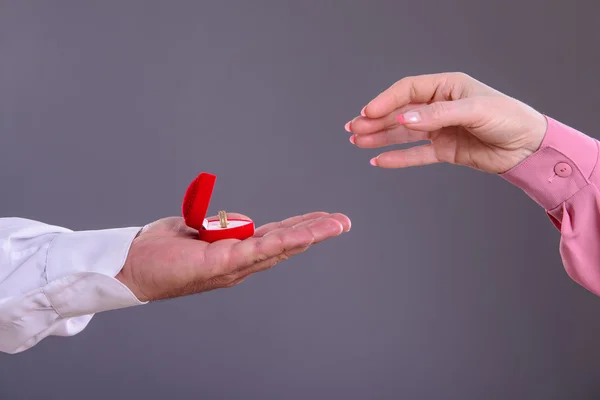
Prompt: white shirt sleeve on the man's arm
<box><xmin>0</xmin><ymin>218</ymin><xmax>145</xmax><ymax>354</ymax></box>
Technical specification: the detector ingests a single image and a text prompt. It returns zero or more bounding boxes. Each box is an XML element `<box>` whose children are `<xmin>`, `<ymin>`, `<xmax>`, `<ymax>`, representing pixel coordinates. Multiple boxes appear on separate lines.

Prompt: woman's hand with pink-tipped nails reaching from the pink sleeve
<box><xmin>346</xmin><ymin>73</ymin><xmax>546</xmax><ymax>173</ymax></box>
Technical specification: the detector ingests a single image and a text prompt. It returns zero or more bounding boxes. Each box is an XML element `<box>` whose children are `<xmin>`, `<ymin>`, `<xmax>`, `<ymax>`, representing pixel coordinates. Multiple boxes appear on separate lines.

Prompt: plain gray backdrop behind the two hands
<box><xmin>0</xmin><ymin>0</ymin><xmax>600</xmax><ymax>400</ymax></box>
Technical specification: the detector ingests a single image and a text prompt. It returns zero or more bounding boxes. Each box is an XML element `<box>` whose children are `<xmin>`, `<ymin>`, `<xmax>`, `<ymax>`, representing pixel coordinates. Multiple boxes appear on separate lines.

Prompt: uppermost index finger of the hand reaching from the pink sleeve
<box><xmin>364</xmin><ymin>73</ymin><xmax>475</xmax><ymax>118</ymax></box>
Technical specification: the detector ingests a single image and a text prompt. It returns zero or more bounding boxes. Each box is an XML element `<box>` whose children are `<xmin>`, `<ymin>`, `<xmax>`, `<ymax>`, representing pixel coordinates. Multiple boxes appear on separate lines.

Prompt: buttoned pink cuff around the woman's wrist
<box><xmin>500</xmin><ymin>117</ymin><xmax>598</xmax><ymax>211</ymax></box>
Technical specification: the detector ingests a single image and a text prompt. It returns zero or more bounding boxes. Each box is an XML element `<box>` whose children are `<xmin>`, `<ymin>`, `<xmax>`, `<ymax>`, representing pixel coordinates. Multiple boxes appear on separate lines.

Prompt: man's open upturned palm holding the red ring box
<box><xmin>116</xmin><ymin>212</ymin><xmax>350</xmax><ymax>301</ymax></box>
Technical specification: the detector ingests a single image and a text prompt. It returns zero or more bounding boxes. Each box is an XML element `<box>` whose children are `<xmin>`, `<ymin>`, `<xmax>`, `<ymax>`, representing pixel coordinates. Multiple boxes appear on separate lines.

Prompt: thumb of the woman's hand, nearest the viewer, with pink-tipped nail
<box><xmin>397</xmin><ymin>98</ymin><xmax>485</xmax><ymax>131</ymax></box>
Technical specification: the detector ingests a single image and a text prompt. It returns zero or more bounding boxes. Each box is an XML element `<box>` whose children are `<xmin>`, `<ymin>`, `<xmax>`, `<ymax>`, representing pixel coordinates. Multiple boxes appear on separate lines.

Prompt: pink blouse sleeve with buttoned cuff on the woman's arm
<box><xmin>501</xmin><ymin>117</ymin><xmax>600</xmax><ymax>296</ymax></box>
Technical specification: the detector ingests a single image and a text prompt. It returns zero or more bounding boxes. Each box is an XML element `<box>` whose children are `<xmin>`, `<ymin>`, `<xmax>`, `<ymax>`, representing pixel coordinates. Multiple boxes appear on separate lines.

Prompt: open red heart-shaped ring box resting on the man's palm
<box><xmin>182</xmin><ymin>172</ymin><xmax>254</xmax><ymax>242</ymax></box>
